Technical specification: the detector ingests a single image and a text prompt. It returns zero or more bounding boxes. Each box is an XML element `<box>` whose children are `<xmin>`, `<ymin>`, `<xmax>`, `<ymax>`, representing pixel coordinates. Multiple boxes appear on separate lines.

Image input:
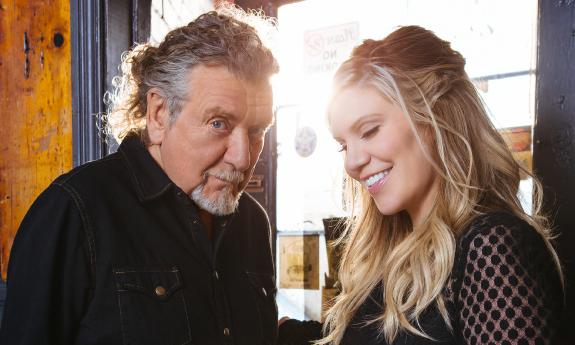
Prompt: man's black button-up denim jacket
<box><xmin>0</xmin><ymin>137</ymin><xmax>277</xmax><ymax>345</ymax></box>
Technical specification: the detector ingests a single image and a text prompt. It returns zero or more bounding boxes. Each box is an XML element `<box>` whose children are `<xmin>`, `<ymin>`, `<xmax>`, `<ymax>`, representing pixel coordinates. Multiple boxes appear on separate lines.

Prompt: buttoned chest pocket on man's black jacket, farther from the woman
<box><xmin>114</xmin><ymin>268</ymin><xmax>191</xmax><ymax>345</ymax></box>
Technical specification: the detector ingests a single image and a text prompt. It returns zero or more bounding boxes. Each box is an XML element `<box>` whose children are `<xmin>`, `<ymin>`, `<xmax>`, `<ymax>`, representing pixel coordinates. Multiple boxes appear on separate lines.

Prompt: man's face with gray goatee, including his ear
<box><xmin>147</xmin><ymin>66</ymin><xmax>273</xmax><ymax>215</ymax></box>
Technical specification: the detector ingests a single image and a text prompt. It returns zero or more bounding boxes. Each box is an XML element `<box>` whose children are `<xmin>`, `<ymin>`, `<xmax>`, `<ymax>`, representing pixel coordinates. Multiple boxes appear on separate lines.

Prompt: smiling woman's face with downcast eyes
<box><xmin>329</xmin><ymin>87</ymin><xmax>439</xmax><ymax>226</ymax></box>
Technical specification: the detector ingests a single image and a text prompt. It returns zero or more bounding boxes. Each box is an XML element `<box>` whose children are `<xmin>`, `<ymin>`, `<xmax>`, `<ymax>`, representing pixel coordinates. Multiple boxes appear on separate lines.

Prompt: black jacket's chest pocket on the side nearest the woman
<box><xmin>246</xmin><ymin>272</ymin><xmax>278</xmax><ymax>345</ymax></box>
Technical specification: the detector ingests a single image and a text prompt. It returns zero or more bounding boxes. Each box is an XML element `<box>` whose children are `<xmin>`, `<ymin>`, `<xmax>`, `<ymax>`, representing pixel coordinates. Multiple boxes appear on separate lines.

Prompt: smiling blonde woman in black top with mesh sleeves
<box><xmin>280</xmin><ymin>26</ymin><xmax>563</xmax><ymax>345</ymax></box>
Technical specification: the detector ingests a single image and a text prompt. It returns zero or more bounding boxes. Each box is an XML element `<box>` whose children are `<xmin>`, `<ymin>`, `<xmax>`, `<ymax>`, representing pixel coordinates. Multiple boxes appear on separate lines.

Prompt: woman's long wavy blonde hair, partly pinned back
<box><xmin>317</xmin><ymin>26</ymin><xmax>561</xmax><ymax>344</ymax></box>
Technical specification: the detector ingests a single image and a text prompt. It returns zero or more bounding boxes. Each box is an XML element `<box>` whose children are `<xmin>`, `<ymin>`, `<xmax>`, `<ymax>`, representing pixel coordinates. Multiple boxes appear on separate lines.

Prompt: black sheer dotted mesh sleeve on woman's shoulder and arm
<box><xmin>456</xmin><ymin>215</ymin><xmax>563</xmax><ymax>344</ymax></box>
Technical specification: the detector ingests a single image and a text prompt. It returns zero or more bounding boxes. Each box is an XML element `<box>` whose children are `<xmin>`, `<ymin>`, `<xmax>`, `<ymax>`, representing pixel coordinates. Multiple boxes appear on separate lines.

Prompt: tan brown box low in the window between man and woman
<box><xmin>278</xmin><ymin>235</ymin><xmax>319</xmax><ymax>290</ymax></box>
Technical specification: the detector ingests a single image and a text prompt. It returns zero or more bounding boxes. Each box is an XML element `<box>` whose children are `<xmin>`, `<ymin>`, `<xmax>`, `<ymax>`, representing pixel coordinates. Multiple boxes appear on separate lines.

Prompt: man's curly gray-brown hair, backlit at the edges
<box><xmin>105</xmin><ymin>6</ymin><xmax>279</xmax><ymax>144</ymax></box>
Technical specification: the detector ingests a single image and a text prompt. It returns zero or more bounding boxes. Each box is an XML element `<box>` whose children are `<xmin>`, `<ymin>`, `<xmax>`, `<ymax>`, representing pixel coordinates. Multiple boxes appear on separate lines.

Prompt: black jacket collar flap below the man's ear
<box><xmin>118</xmin><ymin>135</ymin><xmax>175</xmax><ymax>201</ymax></box>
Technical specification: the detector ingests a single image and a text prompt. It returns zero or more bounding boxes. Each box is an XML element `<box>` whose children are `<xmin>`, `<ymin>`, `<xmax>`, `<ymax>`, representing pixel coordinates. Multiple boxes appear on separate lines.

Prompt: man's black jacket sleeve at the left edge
<box><xmin>0</xmin><ymin>184</ymin><xmax>94</xmax><ymax>345</ymax></box>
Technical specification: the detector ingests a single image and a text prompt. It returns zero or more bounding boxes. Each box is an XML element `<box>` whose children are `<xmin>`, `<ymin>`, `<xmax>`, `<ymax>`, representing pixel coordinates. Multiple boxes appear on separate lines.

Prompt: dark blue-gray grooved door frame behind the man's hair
<box><xmin>70</xmin><ymin>0</ymin><xmax>152</xmax><ymax>166</ymax></box>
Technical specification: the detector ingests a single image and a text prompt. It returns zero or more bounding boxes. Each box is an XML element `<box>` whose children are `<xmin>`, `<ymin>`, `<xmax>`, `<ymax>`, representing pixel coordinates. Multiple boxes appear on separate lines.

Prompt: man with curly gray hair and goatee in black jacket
<box><xmin>0</xmin><ymin>6</ymin><xmax>277</xmax><ymax>345</ymax></box>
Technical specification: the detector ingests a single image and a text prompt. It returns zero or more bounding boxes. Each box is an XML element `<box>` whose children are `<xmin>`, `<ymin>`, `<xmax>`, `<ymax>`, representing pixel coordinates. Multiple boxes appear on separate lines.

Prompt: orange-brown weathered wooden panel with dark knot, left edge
<box><xmin>0</xmin><ymin>0</ymin><xmax>72</xmax><ymax>279</ymax></box>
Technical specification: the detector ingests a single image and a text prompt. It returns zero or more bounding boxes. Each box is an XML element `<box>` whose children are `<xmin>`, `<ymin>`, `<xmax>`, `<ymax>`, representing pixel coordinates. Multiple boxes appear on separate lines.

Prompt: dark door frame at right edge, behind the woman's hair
<box><xmin>533</xmin><ymin>0</ymin><xmax>575</xmax><ymax>344</ymax></box>
